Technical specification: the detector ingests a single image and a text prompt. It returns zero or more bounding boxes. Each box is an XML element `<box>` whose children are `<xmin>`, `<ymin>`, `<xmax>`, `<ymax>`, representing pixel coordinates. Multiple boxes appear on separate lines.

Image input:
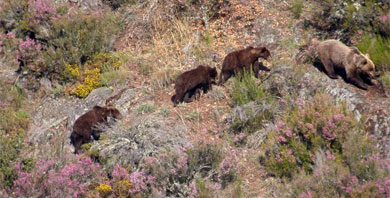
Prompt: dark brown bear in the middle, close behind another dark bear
<box><xmin>171</xmin><ymin>65</ymin><xmax>218</xmax><ymax>107</ymax></box>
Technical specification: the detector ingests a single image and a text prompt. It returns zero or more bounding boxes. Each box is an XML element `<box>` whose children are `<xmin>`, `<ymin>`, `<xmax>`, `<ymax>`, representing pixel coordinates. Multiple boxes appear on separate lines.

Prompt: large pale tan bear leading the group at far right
<box><xmin>312</xmin><ymin>39</ymin><xmax>378</xmax><ymax>90</ymax></box>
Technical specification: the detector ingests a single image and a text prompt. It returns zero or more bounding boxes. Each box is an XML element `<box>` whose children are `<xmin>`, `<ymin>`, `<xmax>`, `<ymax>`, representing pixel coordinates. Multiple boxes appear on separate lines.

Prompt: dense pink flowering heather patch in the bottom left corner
<box><xmin>8</xmin><ymin>156</ymin><xmax>102</xmax><ymax>197</ymax></box>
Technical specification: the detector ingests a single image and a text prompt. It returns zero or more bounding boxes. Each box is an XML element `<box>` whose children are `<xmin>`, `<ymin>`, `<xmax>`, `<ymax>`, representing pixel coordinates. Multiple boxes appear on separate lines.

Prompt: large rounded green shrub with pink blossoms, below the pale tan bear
<box><xmin>261</xmin><ymin>94</ymin><xmax>357</xmax><ymax>177</ymax></box>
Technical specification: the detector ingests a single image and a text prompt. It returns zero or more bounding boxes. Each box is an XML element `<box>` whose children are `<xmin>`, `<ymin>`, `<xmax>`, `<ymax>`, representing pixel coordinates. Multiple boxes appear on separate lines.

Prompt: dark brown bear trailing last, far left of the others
<box><xmin>70</xmin><ymin>106</ymin><xmax>122</xmax><ymax>154</ymax></box>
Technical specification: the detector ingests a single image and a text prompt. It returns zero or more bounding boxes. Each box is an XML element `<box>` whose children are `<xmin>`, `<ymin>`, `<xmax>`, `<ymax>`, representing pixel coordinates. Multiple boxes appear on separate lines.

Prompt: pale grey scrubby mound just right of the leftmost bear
<box><xmin>90</xmin><ymin>117</ymin><xmax>187</xmax><ymax>169</ymax></box>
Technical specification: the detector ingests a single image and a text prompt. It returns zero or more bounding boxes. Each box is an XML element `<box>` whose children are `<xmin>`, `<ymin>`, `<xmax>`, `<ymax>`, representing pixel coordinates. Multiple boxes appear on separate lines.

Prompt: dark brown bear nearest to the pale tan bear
<box><xmin>218</xmin><ymin>46</ymin><xmax>271</xmax><ymax>85</ymax></box>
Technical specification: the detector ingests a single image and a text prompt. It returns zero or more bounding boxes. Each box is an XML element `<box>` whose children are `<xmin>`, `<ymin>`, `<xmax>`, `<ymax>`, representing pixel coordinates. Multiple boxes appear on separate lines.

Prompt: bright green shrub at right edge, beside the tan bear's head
<box><xmin>357</xmin><ymin>35</ymin><xmax>390</xmax><ymax>72</ymax></box>
